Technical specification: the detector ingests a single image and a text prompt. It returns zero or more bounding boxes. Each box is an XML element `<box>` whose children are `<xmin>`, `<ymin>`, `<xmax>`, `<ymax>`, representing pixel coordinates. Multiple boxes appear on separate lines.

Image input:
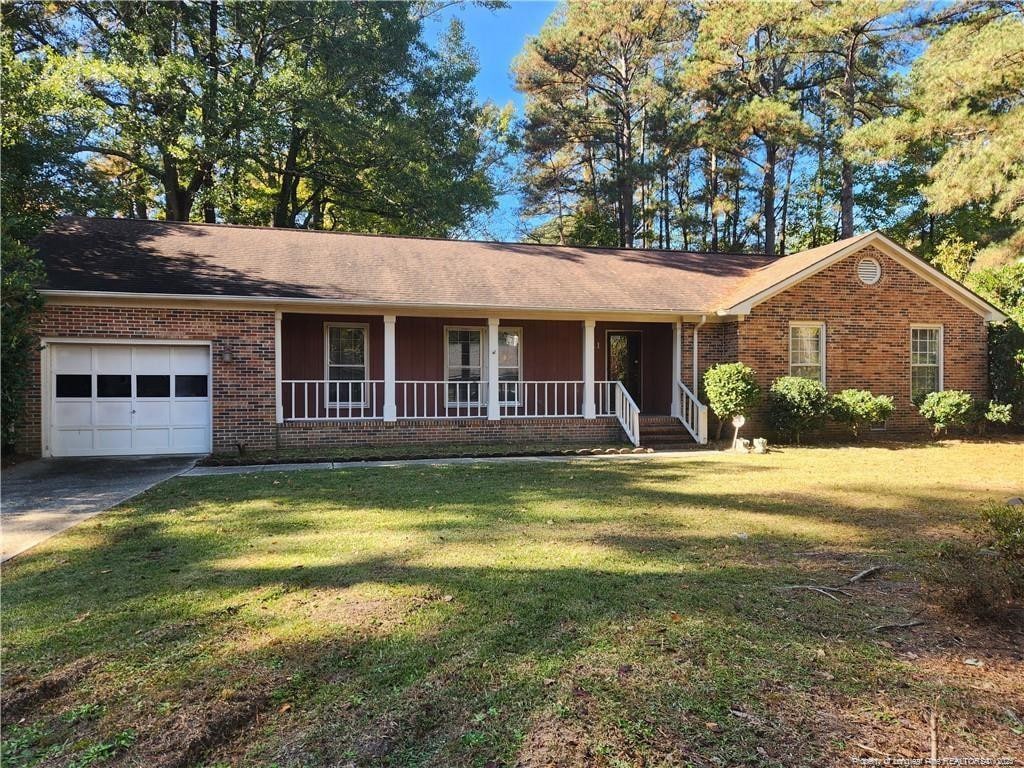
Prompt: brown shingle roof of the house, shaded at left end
<box><xmin>34</xmin><ymin>217</ymin><xmax>849</xmax><ymax>312</ymax></box>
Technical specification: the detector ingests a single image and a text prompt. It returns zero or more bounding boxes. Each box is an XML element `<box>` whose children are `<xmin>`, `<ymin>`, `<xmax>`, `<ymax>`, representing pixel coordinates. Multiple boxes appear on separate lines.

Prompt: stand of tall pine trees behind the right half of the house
<box><xmin>515</xmin><ymin>0</ymin><xmax>1024</xmax><ymax>268</ymax></box>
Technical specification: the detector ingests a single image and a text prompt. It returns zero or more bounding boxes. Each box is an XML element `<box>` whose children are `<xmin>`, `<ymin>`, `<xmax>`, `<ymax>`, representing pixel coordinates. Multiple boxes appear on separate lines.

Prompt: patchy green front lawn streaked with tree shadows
<box><xmin>2</xmin><ymin>441</ymin><xmax>1024</xmax><ymax>768</ymax></box>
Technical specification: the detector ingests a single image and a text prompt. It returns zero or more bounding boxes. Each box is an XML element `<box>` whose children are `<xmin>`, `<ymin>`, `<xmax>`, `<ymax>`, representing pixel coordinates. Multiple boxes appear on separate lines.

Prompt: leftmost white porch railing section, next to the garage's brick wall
<box><xmin>281</xmin><ymin>379</ymin><xmax>384</xmax><ymax>421</ymax></box>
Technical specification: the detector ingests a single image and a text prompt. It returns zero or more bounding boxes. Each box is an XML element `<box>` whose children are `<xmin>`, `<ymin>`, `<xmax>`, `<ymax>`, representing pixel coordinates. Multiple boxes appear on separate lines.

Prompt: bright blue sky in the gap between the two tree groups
<box><xmin>427</xmin><ymin>0</ymin><xmax>556</xmax><ymax>241</ymax></box>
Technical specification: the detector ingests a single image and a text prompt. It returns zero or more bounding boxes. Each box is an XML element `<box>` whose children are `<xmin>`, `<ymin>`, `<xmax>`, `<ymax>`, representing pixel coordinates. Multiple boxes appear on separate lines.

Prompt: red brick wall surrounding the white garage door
<box><xmin>18</xmin><ymin>304</ymin><xmax>274</xmax><ymax>455</ymax></box>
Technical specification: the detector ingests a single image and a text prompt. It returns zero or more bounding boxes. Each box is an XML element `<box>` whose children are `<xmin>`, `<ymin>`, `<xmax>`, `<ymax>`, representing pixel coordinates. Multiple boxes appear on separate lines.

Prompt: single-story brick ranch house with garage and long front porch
<box><xmin>20</xmin><ymin>218</ymin><xmax>1005</xmax><ymax>456</ymax></box>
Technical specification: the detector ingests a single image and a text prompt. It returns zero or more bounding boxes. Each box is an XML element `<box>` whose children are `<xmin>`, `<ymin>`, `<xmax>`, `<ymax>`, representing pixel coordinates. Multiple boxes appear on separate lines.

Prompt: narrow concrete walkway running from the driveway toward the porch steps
<box><xmin>182</xmin><ymin>450</ymin><xmax>718</xmax><ymax>477</ymax></box>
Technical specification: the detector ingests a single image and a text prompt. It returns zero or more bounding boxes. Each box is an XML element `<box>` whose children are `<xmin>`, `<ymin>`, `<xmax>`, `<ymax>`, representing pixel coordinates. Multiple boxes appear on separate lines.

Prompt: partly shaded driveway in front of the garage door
<box><xmin>0</xmin><ymin>456</ymin><xmax>197</xmax><ymax>560</ymax></box>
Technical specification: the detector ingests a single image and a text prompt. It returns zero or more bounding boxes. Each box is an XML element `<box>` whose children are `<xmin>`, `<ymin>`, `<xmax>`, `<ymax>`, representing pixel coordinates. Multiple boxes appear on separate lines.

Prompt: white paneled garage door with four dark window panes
<box><xmin>50</xmin><ymin>343</ymin><xmax>210</xmax><ymax>456</ymax></box>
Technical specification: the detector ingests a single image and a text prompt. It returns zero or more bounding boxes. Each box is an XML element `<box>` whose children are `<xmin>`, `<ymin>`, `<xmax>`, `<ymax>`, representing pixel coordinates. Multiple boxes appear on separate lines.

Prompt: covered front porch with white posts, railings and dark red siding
<box><xmin>275</xmin><ymin>312</ymin><xmax>708</xmax><ymax>445</ymax></box>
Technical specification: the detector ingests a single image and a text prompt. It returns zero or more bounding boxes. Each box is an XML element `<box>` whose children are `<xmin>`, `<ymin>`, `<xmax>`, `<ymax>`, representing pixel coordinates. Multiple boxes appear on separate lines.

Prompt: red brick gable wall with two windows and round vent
<box><xmin>736</xmin><ymin>249</ymin><xmax>988</xmax><ymax>434</ymax></box>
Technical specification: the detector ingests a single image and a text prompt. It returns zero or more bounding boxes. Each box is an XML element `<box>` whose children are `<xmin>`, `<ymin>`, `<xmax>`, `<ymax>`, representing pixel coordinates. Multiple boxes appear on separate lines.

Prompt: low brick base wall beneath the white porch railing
<box><xmin>278</xmin><ymin>418</ymin><xmax>625</xmax><ymax>449</ymax></box>
